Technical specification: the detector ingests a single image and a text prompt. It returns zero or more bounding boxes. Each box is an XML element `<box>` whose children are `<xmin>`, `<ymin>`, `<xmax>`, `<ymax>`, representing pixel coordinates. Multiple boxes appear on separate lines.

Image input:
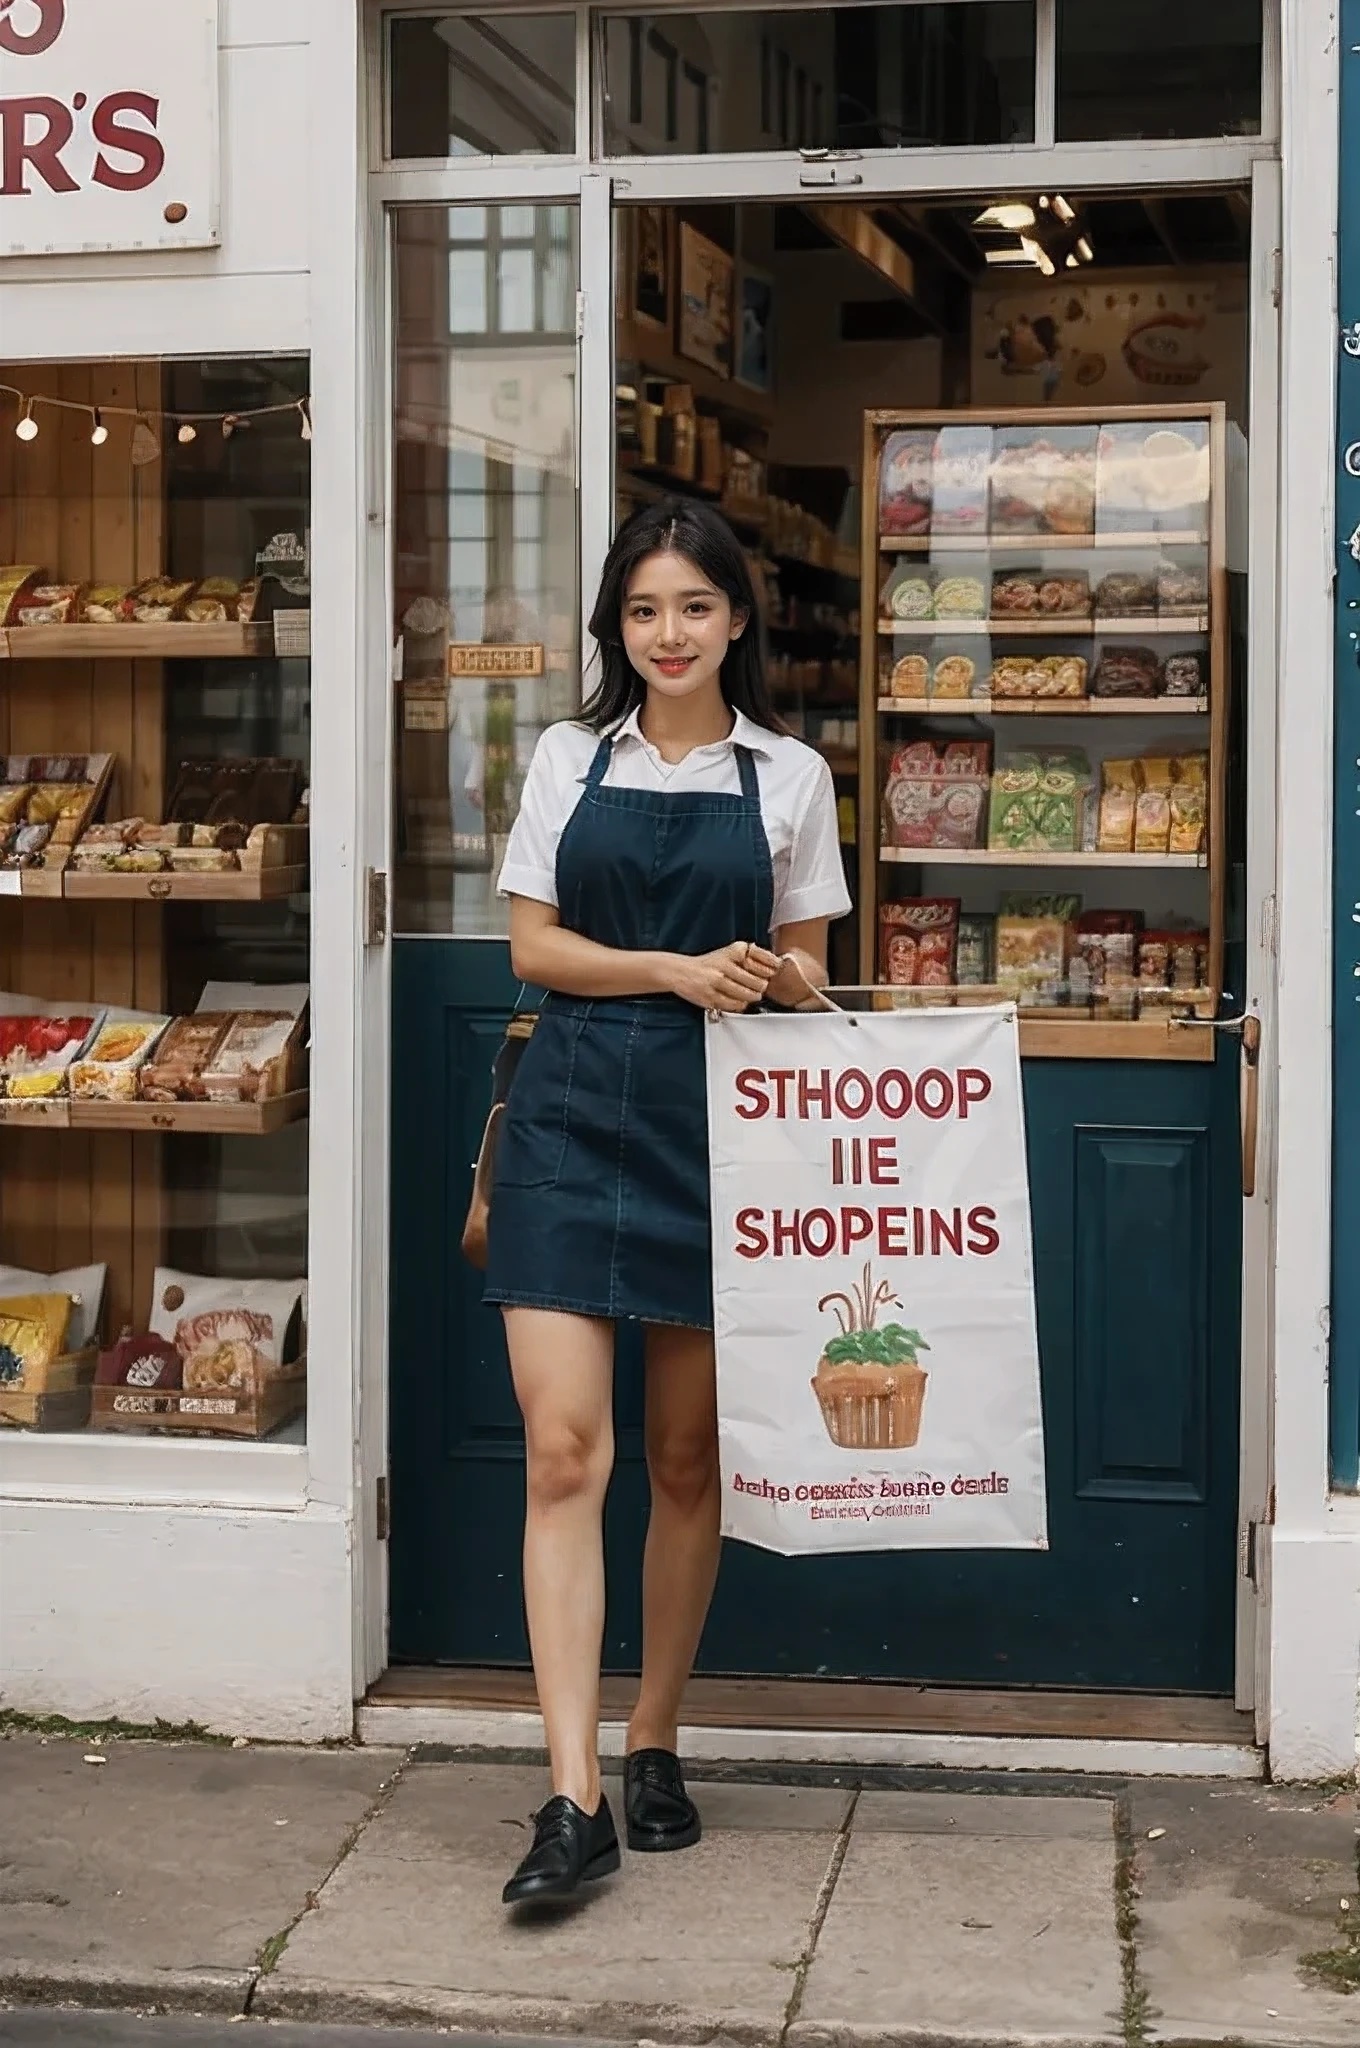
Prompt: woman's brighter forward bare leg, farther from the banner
<box><xmin>504</xmin><ymin>1309</ymin><xmax>614</xmax><ymax>1812</ymax></box>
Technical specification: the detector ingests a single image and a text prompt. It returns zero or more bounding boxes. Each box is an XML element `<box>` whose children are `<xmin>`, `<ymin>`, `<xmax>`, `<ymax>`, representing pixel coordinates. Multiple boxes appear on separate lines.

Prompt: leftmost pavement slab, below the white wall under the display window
<box><xmin>0</xmin><ymin>1735</ymin><xmax>399</xmax><ymax>2011</ymax></box>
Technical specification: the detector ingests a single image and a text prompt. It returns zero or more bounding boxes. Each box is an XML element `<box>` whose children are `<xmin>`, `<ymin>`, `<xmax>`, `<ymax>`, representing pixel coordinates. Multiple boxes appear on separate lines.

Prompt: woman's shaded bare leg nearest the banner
<box><xmin>627</xmin><ymin>1327</ymin><xmax>721</xmax><ymax>1753</ymax></box>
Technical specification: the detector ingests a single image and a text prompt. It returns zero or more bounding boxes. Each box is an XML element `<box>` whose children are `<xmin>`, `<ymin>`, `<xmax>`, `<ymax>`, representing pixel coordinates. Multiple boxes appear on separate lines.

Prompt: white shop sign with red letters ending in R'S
<box><xmin>0</xmin><ymin>0</ymin><xmax>219</xmax><ymax>256</ymax></box>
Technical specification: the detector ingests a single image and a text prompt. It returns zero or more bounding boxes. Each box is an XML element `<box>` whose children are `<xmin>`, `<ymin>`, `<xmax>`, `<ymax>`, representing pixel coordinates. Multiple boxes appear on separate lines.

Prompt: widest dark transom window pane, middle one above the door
<box><xmin>602</xmin><ymin>0</ymin><xmax>1034</xmax><ymax>156</ymax></box>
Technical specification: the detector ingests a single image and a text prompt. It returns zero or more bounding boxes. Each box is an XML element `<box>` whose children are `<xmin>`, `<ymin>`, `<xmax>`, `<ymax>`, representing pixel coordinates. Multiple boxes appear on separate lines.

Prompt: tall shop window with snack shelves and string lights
<box><xmin>0</xmin><ymin>358</ymin><xmax>311</xmax><ymax>1442</ymax></box>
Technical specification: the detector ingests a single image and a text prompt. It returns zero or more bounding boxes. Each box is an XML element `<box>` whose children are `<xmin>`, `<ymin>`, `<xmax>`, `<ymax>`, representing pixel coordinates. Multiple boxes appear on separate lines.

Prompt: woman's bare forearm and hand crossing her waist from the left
<box><xmin>510</xmin><ymin>897</ymin><xmax>778</xmax><ymax>1010</ymax></box>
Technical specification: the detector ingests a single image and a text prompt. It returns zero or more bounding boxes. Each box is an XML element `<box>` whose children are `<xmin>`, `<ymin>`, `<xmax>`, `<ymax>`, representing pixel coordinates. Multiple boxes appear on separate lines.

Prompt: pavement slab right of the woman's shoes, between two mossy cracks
<box><xmin>789</xmin><ymin>1792</ymin><xmax>1124</xmax><ymax>2048</ymax></box>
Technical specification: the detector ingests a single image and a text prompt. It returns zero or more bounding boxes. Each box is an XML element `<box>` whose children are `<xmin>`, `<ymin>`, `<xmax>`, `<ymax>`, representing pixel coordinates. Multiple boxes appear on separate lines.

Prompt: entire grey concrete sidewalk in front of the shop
<box><xmin>0</xmin><ymin>1735</ymin><xmax>1360</xmax><ymax>2048</ymax></box>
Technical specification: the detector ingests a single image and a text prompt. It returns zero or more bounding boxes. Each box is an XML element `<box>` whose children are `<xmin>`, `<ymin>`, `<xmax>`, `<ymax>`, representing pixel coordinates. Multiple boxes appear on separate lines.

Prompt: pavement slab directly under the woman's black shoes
<box><xmin>254</xmin><ymin>1765</ymin><xmax>848</xmax><ymax>2042</ymax></box>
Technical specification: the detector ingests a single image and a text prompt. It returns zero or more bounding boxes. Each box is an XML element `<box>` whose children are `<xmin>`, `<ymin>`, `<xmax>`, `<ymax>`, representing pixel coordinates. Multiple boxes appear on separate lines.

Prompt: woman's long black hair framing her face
<box><xmin>580</xmin><ymin>498</ymin><xmax>787</xmax><ymax>733</ymax></box>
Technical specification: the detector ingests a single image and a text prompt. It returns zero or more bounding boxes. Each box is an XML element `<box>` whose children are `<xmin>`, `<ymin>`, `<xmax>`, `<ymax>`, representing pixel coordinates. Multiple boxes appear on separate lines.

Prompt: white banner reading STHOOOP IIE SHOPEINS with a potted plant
<box><xmin>707</xmin><ymin>1006</ymin><xmax>1047</xmax><ymax>1556</ymax></box>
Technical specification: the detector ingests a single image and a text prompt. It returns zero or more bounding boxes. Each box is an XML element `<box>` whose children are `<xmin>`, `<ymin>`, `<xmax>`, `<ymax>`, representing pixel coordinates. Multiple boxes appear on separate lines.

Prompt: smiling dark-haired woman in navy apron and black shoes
<box><xmin>485</xmin><ymin>500</ymin><xmax>850</xmax><ymax>1905</ymax></box>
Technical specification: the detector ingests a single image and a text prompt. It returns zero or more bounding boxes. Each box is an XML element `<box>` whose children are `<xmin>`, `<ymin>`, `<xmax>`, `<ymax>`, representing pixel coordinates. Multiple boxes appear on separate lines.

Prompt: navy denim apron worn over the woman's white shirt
<box><xmin>485</xmin><ymin>739</ymin><xmax>774</xmax><ymax>1329</ymax></box>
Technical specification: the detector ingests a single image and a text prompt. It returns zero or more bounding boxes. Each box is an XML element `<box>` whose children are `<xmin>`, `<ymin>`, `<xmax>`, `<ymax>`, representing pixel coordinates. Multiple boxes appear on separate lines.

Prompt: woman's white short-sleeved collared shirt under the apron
<box><xmin>498</xmin><ymin>711</ymin><xmax>850</xmax><ymax>932</ymax></box>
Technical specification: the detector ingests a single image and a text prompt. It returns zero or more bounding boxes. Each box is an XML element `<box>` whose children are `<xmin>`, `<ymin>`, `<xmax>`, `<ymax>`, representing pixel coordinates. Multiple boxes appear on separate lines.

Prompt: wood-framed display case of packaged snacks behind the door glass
<box><xmin>858</xmin><ymin>406</ymin><xmax>1229</xmax><ymax>1059</ymax></box>
